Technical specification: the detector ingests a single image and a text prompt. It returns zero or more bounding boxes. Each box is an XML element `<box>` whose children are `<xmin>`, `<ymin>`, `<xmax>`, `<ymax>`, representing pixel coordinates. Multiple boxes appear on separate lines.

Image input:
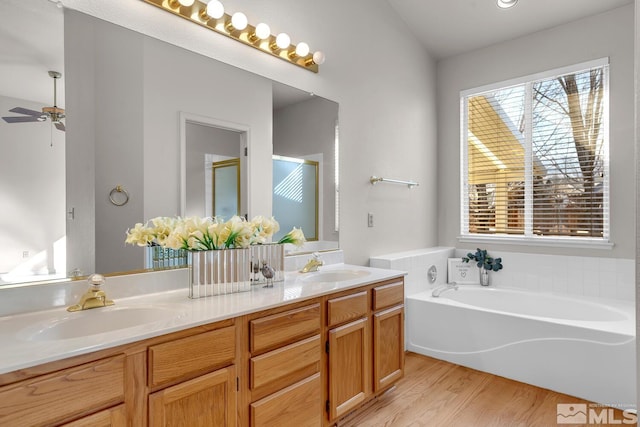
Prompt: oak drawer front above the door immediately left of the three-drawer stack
<box><xmin>149</xmin><ymin>326</ymin><xmax>236</xmax><ymax>387</ymax></box>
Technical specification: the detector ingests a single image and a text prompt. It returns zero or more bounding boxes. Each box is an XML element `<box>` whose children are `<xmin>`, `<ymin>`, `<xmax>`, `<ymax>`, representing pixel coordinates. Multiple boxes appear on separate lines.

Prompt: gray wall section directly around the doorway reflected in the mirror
<box><xmin>144</xmin><ymin>37</ymin><xmax>273</xmax><ymax>224</ymax></box>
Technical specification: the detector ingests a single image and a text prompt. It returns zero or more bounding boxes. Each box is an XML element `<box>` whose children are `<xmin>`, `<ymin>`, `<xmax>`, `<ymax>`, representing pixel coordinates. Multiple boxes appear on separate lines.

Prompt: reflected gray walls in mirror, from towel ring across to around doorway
<box><xmin>65</xmin><ymin>10</ymin><xmax>272</xmax><ymax>274</ymax></box>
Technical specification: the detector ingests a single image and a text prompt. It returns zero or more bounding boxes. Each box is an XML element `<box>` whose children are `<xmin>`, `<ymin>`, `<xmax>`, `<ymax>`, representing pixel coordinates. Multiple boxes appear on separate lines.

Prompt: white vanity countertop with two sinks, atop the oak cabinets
<box><xmin>0</xmin><ymin>264</ymin><xmax>406</xmax><ymax>374</ymax></box>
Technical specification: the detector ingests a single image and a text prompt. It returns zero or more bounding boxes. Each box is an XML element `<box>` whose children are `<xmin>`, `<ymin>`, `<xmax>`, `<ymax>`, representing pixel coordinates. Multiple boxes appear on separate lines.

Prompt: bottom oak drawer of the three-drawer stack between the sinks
<box><xmin>251</xmin><ymin>373</ymin><xmax>322</xmax><ymax>427</ymax></box>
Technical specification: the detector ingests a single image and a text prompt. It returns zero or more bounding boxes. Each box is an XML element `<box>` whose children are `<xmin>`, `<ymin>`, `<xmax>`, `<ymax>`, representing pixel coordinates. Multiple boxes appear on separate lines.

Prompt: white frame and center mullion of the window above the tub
<box><xmin>458</xmin><ymin>57</ymin><xmax>613</xmax><ymax>249</ymax></box>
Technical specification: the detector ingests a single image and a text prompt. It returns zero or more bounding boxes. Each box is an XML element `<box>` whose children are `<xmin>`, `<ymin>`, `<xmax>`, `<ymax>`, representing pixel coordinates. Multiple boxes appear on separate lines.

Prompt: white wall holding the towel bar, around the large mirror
<box><xmin>65</xmin><ymin>0</ymin><xmax>437</xmax><ymax>264</ymax></box>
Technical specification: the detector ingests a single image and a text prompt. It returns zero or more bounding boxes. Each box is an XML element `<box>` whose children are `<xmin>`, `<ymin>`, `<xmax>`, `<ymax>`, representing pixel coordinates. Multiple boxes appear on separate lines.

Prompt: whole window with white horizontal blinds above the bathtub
<box><xmin>461</xmin><ymin>60</ymin><xmax>609</xmax><ymax>241</ymax></box>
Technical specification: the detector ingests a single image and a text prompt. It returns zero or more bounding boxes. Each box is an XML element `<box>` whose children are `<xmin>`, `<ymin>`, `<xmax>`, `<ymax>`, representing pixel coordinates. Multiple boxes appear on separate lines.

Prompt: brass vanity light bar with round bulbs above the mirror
<box><xmin>142</xmin><ymin>0</ymin><xmax>325</xmax><ymax>73</ymax></box>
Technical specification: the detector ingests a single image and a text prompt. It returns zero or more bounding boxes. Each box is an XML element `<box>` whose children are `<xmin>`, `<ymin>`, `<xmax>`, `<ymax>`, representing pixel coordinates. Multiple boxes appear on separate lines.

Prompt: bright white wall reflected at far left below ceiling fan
<box><xmin>0</xmin><ymin>96</ymin><xmax>65</xmax><ymax>281</ymax></box>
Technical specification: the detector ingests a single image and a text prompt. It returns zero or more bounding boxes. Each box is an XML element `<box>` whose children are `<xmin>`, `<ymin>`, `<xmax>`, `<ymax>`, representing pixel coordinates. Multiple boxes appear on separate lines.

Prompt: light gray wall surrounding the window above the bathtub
<box><xmin>437</xmin><ymin>5</ymin><xmax>635</xmax><ymax>259</ymax></box>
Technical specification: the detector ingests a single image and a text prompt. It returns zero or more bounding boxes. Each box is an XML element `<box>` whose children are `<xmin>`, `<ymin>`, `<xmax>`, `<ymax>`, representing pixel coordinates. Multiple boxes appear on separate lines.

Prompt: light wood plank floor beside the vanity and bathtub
<box><xmin>339</xmin><ymin>353</ymin><xmax>631</xmax><ymax>427</ymax></box>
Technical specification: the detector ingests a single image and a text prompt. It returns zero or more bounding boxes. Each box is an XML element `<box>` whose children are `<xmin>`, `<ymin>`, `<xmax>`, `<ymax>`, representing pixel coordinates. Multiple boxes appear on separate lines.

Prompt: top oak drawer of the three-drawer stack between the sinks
<box><xmin>250</xmin><ymin>304</ymin><xmax>320</xmax><ymax>353</ymax></box>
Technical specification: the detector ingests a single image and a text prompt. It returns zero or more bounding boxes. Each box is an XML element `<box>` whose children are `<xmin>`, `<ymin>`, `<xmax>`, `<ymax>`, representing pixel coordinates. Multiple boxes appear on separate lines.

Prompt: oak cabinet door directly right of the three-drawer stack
<box><xmin>329</xmin><ymin>317</ymin><xmax>371</xmax><ymax>420</ymax></box>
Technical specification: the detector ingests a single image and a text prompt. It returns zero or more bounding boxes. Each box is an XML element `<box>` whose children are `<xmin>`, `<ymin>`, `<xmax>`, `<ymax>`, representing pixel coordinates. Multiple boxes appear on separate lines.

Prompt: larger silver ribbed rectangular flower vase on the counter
<box><xmin>189</xmin><ymin>248</ymin><xmax>251</xmax><ymax>298</ymax></box>
